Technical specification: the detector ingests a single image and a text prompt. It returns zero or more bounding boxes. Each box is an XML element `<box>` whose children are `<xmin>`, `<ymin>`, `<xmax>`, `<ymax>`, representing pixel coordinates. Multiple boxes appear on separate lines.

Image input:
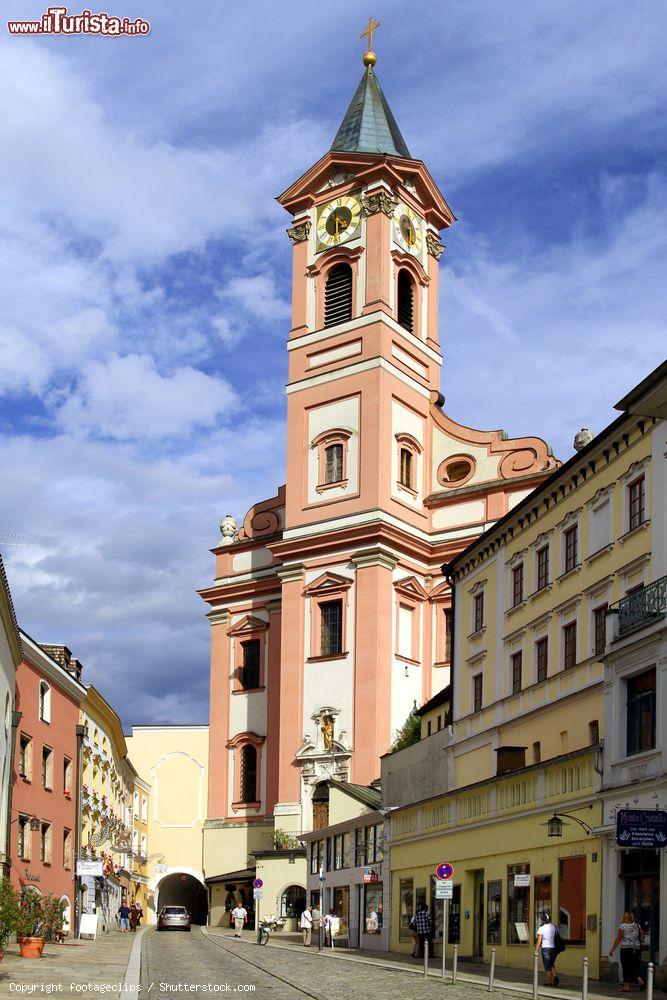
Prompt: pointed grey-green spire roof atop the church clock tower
<box><xmin>331</xmin><ymin>66</ymin><xmax>412</xmax><ymax>160</ymax></box>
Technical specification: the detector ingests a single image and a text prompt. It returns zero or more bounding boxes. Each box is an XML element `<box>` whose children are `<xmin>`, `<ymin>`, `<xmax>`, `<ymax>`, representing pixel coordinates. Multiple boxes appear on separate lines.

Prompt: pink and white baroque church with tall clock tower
<box><xmin>201</xmin><ymin>52</ymin><xmax>559</xmax><ymax>924</ymax></box>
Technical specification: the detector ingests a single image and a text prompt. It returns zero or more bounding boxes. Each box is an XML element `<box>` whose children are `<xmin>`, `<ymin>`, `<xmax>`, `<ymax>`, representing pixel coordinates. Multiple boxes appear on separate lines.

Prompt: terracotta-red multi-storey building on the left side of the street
<box><xmin>10</xmin><ymin>632</ymin><xmax>86</xmax><ymax>926</ymax></box>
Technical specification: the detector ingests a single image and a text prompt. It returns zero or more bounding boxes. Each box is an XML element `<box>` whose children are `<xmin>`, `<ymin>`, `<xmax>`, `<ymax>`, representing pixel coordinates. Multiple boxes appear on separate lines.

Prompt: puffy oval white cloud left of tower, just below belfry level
<box><xmin>58</xmin><ymin>354</ymin><xmax>237</xmax><ymax>440</ymax></box>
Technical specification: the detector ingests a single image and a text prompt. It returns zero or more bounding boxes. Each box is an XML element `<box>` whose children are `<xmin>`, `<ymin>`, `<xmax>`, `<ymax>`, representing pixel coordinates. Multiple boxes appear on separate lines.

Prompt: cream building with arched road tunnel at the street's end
<box><xmin>126</xmin><ymin>726</ymin><xmax>208</xmax><ymax>923</ymax></box>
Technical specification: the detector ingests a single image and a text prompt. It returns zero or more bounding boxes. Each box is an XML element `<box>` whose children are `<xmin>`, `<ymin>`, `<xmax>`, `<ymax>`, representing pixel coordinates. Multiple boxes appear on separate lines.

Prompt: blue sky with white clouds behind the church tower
<box><xmin>0</xmin><ymin>0</ymin><xmax>667</xmax><ymax>726</ymax></box>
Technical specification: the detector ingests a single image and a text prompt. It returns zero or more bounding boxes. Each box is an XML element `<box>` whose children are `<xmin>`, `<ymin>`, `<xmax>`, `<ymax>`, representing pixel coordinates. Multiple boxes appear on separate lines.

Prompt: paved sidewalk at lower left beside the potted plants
<box><xmin>0</xmin><ymin>931</ymin><xmax>136</xmax><ymax>998</ymax></box>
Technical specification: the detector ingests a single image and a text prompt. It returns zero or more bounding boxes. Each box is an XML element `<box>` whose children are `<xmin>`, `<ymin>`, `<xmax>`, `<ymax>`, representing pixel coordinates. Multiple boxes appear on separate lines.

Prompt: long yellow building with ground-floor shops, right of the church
<box><xmin>382</xmin><ymin>364</ymin><xmax>664</xmax><ymax>977</ymax></box>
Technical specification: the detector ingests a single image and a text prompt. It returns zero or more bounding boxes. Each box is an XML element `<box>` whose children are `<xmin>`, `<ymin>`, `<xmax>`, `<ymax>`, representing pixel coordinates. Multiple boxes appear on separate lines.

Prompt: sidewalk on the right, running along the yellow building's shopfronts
<box><xmin>202</xmin><ymin>927</ymin><xmax>648</xmax><ymax>1000</ymax></box>
